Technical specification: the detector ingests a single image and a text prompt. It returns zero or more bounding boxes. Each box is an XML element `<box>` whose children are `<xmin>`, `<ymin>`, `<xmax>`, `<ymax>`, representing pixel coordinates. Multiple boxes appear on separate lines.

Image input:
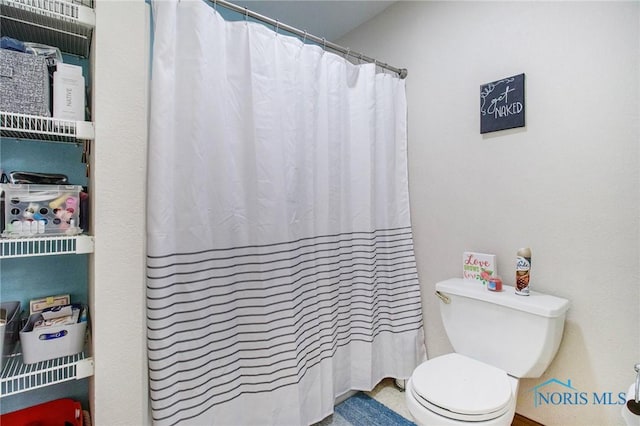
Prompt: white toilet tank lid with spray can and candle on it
<box><xmin>436</xmin><ymin>278</ymin><xmax>569</xmax><ymax>318</ymax></box>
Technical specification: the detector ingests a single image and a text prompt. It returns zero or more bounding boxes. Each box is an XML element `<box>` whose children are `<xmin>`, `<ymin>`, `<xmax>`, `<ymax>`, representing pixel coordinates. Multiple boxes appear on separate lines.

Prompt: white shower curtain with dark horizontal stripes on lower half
<box><xmin>147</xmin><ymin>0</ymin><xmax>425</xmax><ymax>426</ymax></box>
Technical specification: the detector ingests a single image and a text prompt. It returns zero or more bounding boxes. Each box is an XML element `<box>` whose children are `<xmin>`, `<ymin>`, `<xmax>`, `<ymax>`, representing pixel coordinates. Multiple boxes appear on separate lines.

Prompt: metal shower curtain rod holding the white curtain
<box><xmin>208</xmin><ymin>0</ymin><xmax>408</xmax><ymax>79</ymax></box>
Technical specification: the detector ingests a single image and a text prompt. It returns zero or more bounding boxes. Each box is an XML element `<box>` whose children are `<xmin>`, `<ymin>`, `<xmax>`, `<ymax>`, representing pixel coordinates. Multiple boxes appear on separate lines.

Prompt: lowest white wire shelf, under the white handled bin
<box><xmin>0</xmin><ymin>346</ymin><xmax>94</xmax><ymax>397</ymax></box>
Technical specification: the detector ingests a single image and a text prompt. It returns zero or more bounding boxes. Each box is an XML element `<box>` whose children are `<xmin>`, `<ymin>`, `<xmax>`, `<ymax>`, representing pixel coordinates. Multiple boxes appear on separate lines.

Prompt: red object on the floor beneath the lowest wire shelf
<box><xmin>0</xmin><ymin>398</ymin><xmax>82</xmax><ymax>426</ymax></box>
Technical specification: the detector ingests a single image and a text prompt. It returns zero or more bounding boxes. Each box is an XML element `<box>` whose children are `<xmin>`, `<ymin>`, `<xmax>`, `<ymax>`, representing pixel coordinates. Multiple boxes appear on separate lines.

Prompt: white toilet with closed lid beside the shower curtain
<box><xmin>405</xmin><ymin>278</ymin><xmax>569</xmax><ymax>426</ymax></box>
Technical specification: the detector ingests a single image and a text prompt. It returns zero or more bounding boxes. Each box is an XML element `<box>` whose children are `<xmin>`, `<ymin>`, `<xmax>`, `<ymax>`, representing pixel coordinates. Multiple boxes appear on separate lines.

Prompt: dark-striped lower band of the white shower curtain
<box><xmin>147</xmin><ymin>228</ymin><xmax>422</xmax><ymax>420</ymax></box>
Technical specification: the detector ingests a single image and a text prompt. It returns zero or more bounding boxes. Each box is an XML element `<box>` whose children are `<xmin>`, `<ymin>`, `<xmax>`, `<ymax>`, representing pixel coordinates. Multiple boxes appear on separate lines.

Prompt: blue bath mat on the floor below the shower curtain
<box><xmin>318</xmin><ymin>392</ymin><xmax>415</xmax><ymax>426</ymax></box>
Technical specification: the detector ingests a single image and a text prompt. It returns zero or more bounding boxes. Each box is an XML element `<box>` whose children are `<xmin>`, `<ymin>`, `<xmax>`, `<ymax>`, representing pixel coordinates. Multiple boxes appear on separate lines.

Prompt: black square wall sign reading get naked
<box><xmin>480</xmin><ymin>74</ymin><xmax>524</xmax><ymax>133</ymax></box>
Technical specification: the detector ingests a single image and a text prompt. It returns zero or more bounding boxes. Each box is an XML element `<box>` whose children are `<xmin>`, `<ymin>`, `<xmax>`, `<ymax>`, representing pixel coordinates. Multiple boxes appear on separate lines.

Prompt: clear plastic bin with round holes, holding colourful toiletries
<box><xmin>0</xmin><ymin>184</ymin><xmax>82</xmax><ymax>238</ymax></box>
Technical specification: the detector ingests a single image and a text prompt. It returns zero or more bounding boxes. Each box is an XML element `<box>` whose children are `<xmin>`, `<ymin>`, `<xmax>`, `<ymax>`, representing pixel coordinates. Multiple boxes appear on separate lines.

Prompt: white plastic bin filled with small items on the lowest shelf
<box><xmin>20</xmin><ymin>298</ymin><xmax>88</xmax><ymax>364</ymax></box>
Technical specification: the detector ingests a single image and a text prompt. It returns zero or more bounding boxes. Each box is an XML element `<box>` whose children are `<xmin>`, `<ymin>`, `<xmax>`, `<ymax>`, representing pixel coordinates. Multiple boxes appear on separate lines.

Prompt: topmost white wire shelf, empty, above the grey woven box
<box><xmin>0</xmin><ymin>0</ymin><xmax>95</xmax><ymax>58</ymax></box>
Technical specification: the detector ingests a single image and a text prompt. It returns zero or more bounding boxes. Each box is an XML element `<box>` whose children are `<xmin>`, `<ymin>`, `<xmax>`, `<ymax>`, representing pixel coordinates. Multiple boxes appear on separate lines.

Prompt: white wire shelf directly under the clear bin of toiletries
<box><xmin>0</xmin><ymin>235</ymin><xmax>94</xmax><ymax>259</ymax></box>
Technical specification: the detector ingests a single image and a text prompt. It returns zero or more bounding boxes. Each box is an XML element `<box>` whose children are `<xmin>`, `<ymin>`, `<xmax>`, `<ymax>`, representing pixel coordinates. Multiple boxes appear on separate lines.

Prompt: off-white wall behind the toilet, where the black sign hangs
<box><xmin>340</xmin><ymin>1</ymin><xmax>640</xmax><ymax>425</ymax></box>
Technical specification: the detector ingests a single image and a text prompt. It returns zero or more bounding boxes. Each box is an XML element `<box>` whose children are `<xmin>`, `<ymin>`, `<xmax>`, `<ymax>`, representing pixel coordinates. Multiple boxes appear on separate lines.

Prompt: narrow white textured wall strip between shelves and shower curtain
<box><xmin>90</xmin><ymin>0</ymin><xmax>149</xmax><ymax>426</ymax></box>
